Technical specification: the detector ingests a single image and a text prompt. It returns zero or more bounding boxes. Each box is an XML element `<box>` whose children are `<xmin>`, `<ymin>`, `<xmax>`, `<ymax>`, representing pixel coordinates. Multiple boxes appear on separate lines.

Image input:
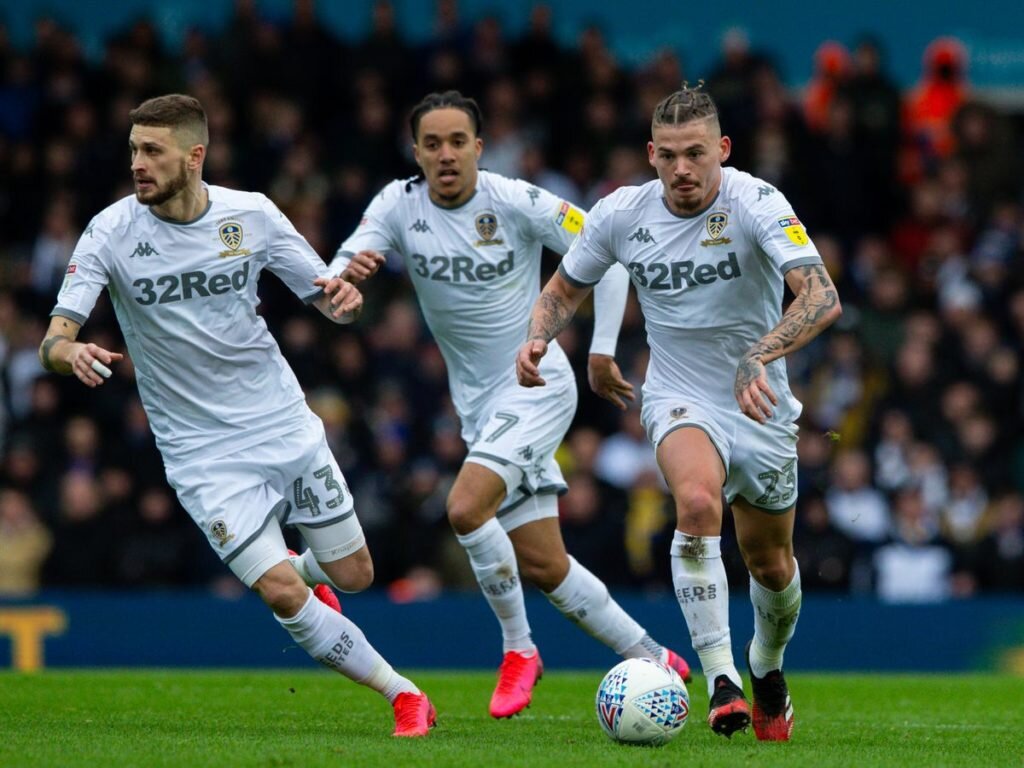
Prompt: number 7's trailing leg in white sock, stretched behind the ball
<box><xmin>509</xmin><ymin>512</ymin><xmax>690</xmax><ymax>680</ymax></box>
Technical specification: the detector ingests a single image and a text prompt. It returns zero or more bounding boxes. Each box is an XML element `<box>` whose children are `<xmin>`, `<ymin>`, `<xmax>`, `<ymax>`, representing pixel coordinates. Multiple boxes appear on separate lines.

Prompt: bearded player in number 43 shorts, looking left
<box><xmin>39</xmin><ymin>94</ymin><xmax>435</xmax><ymax>736</ymax></box>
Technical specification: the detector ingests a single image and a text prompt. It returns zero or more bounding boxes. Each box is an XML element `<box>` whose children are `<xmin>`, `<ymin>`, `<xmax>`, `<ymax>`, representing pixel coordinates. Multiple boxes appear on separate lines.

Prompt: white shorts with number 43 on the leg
<box><xmin>167</xmin><ymin>419</ymin><xmax>366</xmax><ymax>586</ymax></box>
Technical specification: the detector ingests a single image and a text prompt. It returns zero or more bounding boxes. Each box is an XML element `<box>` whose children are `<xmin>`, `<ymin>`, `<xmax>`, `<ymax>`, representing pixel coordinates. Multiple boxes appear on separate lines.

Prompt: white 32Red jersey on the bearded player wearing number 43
<box><xmin>52</xmin><ymin>186</ymin><xmax>329</xmax><ymax>465</ymax></box>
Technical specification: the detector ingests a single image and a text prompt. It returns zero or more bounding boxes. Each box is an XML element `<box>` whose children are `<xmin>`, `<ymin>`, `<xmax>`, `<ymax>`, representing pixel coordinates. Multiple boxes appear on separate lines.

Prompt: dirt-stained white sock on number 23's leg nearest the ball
<box><xmin>672</xmin><ymin>530</ymin><xmax>743</xmax><ymax>696</ymax></box>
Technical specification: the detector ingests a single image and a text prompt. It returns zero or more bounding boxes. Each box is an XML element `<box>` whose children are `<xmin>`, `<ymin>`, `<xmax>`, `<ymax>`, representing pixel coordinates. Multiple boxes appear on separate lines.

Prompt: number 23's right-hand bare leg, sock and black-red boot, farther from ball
<box><xmin>732</xmin><ymin>499</ymin><xmax>801</xmax><ymax>741</ymax></box>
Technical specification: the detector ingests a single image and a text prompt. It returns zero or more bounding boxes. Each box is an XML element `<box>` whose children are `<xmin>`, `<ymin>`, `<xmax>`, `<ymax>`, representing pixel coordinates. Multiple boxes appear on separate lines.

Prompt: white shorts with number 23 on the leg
<box><xmin>640</xmin><ymin>392</ymin><xmax>799</xmax><ymax>512</ymax></box>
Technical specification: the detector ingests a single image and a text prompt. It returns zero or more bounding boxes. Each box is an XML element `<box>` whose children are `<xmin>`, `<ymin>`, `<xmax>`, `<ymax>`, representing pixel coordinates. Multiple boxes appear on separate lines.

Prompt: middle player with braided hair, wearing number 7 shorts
<box><xmin>332</xmin><ymin>91</ymin><xmax>689</xmax><ymax>718</ymax></box>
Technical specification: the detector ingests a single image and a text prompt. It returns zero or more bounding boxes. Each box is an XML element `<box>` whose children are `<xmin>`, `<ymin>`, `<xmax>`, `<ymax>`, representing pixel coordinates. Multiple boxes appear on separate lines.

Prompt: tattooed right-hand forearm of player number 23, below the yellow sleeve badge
<box><xmin>744</xmin><ymin>264</ymin><xmax>842</xmax><ymax>362</ymax></box>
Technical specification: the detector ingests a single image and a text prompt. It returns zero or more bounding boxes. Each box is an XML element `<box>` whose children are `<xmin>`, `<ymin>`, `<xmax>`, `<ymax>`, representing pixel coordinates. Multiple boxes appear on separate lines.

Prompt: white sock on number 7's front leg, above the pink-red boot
<box><xmin>457</xmin><ymin>517</ymin><xmax>537</xmax><ymax>653</ymax></box>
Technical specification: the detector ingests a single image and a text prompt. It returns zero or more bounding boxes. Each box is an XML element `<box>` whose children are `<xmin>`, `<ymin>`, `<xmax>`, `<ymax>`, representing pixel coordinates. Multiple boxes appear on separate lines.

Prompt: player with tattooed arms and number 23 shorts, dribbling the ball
<box><xmin>516</xmin><ymin>85</ymin><xmax>841</xmax><ymax>740</ymax></box>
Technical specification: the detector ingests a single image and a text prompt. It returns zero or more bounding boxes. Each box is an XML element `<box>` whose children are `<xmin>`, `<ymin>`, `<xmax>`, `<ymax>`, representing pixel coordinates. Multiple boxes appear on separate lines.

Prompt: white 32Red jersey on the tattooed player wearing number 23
<box><xmin>559</xmin><ymin>168</ymin><xmax>821</xmax><ymax>422</ymax></box>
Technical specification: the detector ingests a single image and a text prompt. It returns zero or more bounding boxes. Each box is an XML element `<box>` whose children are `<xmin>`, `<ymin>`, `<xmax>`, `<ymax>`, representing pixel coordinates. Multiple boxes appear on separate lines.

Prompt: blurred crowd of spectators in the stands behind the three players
<box><xmin>0</xmin><ymin>0</ymin><xmax>1024</xmax><ymax>601</ymax></box>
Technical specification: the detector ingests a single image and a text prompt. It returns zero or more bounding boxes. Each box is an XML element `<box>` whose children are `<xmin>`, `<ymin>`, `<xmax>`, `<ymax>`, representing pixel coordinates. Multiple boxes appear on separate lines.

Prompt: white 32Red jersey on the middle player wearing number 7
<box><xmin>332</xmin><ymin>171</ymin><xmax>589</xmax><ymax>423</ymax></box>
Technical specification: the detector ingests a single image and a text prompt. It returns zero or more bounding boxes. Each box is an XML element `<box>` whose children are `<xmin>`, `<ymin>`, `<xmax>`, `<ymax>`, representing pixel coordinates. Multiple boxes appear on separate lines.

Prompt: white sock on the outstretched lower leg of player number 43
<box><xmin>275</xmin><ymin>592</ymin><xmax>420</xmax><ymax>701</ymax></box>
